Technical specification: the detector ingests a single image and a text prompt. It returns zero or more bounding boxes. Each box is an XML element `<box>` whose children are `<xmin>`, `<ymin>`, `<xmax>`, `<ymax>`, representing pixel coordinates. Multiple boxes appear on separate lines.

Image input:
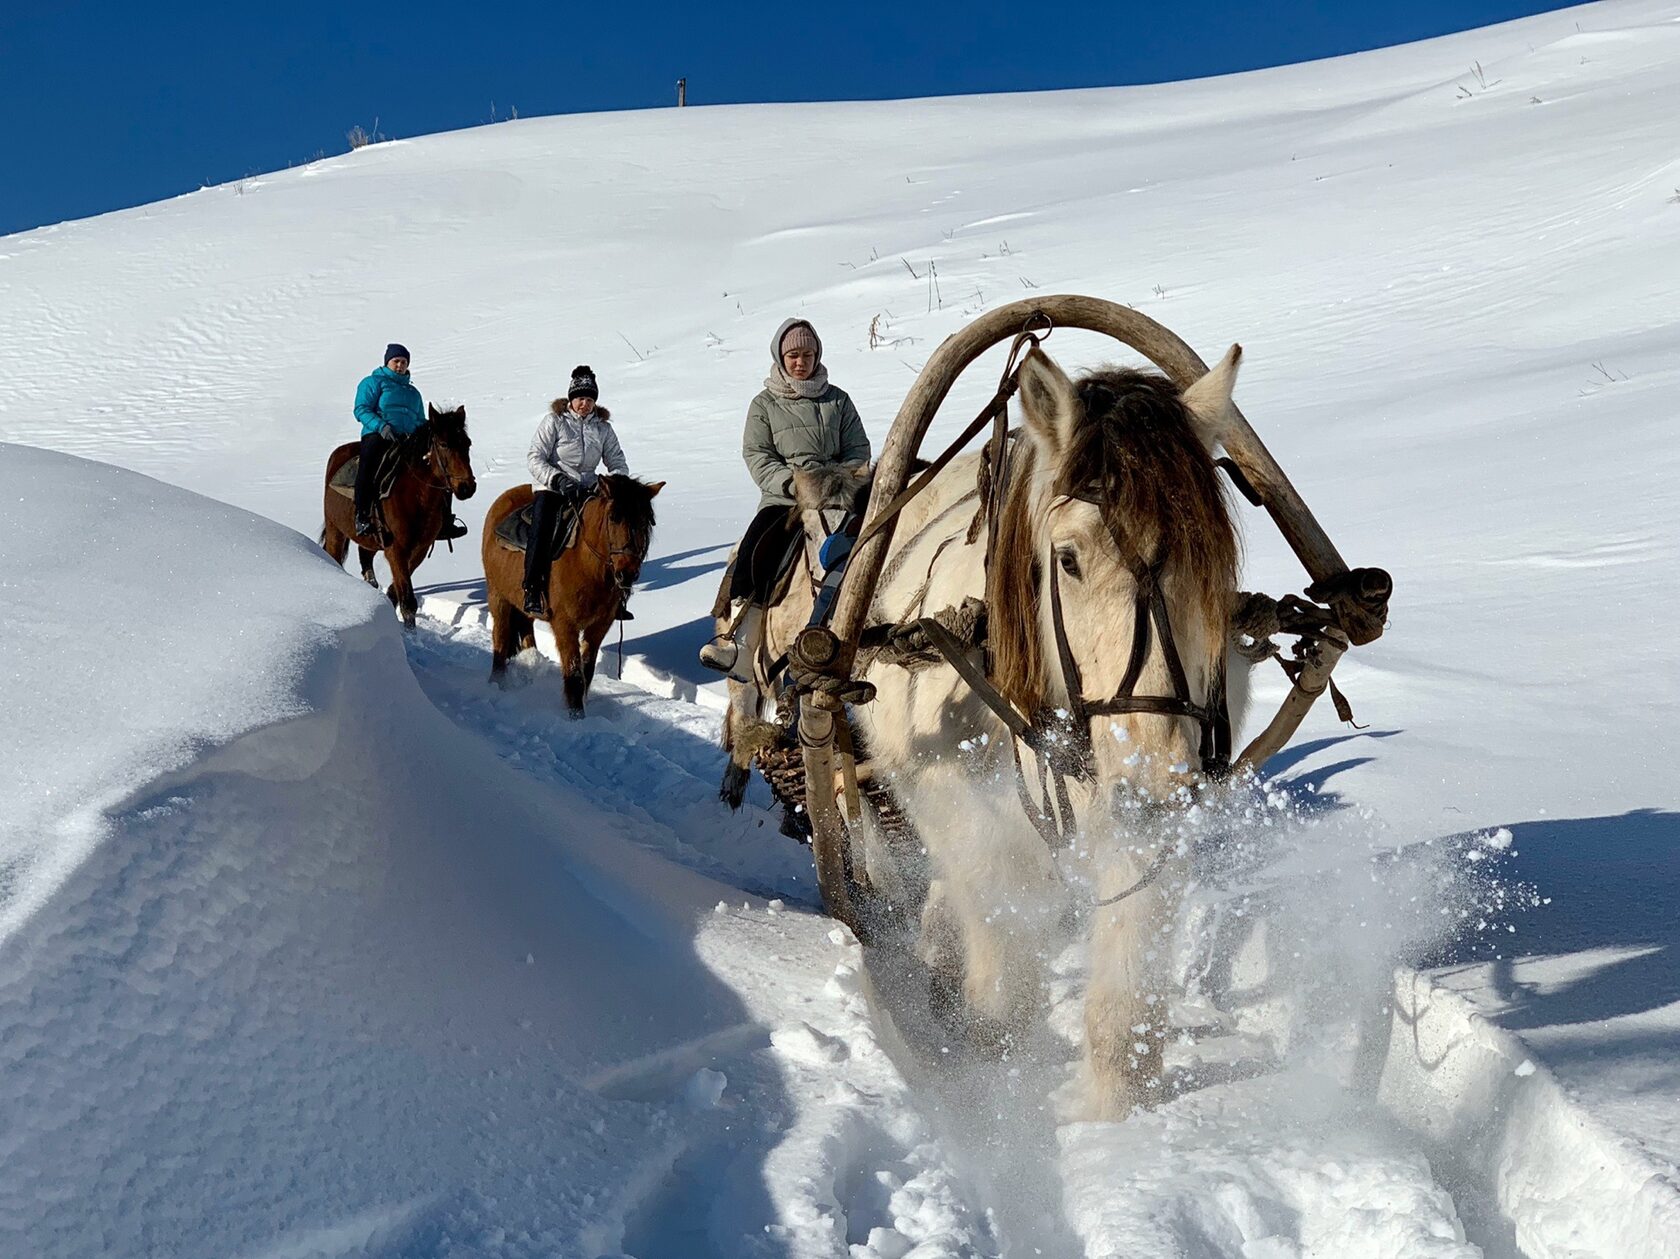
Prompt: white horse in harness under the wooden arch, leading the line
<box><xmin>853</xmin><ymin>346</ymin><xmax>1247</xmax><ymax>1118</ymax></box>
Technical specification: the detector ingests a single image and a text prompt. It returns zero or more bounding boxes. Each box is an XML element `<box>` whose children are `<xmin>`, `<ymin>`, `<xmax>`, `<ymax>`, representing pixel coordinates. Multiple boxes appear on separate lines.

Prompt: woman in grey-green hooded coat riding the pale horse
<box><xmin>701</xmin><ymin>319</ymin><xmax>870</xmax><ymax>681</ymax></box>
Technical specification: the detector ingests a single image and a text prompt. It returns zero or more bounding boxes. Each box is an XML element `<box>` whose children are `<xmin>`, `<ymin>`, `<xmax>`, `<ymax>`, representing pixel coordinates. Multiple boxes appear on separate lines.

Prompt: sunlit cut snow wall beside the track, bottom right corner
<box><xmin>1378</xmin><ymin>967</ymin><xmax>1680</xmax><ymax>1259</ymax></box>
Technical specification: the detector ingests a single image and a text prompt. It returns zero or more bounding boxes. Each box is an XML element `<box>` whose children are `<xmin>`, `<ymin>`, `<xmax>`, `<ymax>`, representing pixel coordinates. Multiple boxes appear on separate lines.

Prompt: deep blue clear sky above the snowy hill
<box><xmin>0</xmin><ymin>0</ymin><xmax>1564</xmax><ymax>234</ymax></box>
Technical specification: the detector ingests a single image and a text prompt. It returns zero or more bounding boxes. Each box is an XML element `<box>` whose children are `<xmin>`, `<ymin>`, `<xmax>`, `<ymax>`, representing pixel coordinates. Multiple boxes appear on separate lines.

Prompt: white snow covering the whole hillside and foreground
<box><xmin>0</xmin><ymin>0</ymin><xmax>1680</xmax><ymax>1259</ymax></box>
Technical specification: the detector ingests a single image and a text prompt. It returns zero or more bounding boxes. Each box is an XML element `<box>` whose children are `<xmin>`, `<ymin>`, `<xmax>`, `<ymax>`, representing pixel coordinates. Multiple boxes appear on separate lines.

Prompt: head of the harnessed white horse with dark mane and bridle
<box><xmin>988</xmin><ymin>348</ymin><xmax>1238</xmax><ymax>807</ymax></box>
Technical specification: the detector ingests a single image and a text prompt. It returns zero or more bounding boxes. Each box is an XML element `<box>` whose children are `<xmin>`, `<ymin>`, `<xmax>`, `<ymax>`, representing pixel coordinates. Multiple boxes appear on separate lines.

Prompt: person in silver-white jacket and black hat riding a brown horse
<box><xmin>524</xmin><ymin>363</ymin><xmax>633</xmax><ymax>620</ymax></box>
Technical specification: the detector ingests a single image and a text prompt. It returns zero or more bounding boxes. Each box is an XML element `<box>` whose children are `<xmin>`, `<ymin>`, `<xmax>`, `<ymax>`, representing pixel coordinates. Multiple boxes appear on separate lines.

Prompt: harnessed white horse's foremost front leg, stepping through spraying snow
<box><xmin>1085</xmin><ymin>862</ymin><xmax>1168</xmax><ymax>1119</ymax></box>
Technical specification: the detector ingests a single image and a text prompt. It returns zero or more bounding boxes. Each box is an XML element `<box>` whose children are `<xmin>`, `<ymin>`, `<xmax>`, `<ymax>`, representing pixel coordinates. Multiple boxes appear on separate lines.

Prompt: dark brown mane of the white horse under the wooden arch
<box><xmin>986</xmin><ymin>368</ymin><xmax>1240</xmax><ymax>713</ymax></box>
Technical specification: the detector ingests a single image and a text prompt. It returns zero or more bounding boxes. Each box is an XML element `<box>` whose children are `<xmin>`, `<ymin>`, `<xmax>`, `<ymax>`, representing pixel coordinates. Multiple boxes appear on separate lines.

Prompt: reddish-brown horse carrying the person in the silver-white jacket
<box><xmin>484</xmin><ymin>476</ymin><xmax>665</xmax><ymax>718</ymax></box>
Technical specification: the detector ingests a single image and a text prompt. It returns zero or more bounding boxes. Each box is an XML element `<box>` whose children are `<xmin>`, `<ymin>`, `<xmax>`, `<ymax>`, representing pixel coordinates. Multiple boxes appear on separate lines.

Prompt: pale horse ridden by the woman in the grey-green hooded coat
<box><xmin>714</xmin><ymin>464</ymin><xmax>870</xmax><ymax>823</ymax></box>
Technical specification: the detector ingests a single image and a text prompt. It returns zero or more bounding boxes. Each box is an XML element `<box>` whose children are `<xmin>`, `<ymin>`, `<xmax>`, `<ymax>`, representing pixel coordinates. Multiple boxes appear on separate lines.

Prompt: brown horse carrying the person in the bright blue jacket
<box><xmin>321</xmin><ymin>405</ymin><xmax>479</xmax><ymax>629</ymax></box>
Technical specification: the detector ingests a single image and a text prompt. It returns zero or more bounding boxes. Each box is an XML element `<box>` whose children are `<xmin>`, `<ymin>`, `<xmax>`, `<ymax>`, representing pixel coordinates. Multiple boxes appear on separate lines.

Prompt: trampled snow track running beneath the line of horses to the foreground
<box><xmin>408</xmin><ymin>619</ymin><xmax>1520</xmax><ymax>1259</ymax></box>
